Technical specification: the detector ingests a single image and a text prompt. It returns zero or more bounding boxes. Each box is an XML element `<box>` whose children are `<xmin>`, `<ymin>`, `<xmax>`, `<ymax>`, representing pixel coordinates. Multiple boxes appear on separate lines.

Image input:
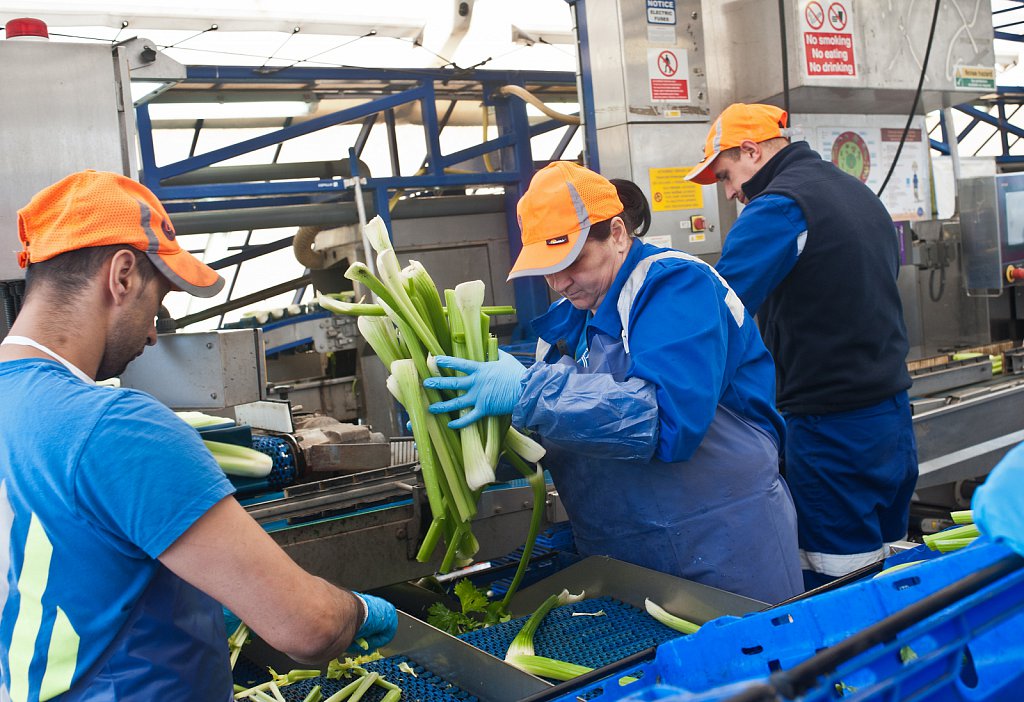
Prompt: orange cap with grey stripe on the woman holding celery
<box><xmin>508</xmin><ymin>161</ymin><xmax>623</xmax><ymax>280</ymax></box>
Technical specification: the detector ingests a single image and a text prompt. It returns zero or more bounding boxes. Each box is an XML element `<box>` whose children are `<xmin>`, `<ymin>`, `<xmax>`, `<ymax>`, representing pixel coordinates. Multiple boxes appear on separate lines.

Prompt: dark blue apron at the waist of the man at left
<box><xmin>60</xmin><ymin>564</ymin><xmax>233</xmax><ymax>702</ymax></box>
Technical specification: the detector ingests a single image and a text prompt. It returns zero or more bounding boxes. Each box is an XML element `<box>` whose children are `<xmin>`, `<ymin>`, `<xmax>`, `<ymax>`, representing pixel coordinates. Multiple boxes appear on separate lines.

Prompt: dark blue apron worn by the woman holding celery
<box><xmin>539</xmin><ymin>258</ymin><xmax>804</xmax><ymax>603</ymax></box>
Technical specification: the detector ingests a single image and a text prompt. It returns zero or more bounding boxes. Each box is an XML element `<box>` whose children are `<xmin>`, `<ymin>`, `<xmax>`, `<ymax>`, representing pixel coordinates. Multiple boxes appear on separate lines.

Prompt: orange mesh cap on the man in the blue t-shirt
<box><xmin>17</xmin><ymin>171</ymin><xmax>224</xmax><ymax>298</ymax></box>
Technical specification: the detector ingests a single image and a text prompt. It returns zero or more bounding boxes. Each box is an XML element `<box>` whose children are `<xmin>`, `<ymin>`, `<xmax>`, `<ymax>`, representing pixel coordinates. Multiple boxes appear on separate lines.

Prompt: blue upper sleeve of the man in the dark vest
<box><xmin>715</xmin><ymin>194</ymin><xmax>807</xmax><ymax>315</ymax></box>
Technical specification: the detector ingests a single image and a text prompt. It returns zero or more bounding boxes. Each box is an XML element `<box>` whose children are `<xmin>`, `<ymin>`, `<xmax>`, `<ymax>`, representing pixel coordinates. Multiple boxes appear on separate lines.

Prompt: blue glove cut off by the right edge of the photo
<box><xmin>971</xmin><ymin>444</ymin><xmax>1024</xmax><ymax>555</ymax></box>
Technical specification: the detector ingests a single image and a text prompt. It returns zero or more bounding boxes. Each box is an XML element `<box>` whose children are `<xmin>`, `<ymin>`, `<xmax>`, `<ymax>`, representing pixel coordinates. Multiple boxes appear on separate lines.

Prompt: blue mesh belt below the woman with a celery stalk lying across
<box><xmin>459</xmin><ymin>597</ymin><xmax>682</xmax><ymax>668</ymax></box>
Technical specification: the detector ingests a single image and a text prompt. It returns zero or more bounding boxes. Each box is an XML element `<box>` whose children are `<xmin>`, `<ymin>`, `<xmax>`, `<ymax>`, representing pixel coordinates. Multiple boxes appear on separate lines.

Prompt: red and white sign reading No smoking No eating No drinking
<box><xmin>801</xmin><ymin>0</ymin><xmax>857</xmax><ymax>78</ymax></box>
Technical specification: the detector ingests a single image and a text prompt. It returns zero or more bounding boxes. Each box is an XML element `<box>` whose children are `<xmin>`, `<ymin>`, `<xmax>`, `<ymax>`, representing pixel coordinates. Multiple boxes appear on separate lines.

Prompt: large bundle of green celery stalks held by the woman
<box><xmin>317</xmin><ymin>217</ymin><xmax>545</xmax><ymax>585</ymax></box>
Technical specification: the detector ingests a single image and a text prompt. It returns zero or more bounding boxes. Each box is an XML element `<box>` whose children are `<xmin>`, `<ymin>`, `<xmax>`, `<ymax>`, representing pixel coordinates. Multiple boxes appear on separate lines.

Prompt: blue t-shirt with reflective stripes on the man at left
<box><xmin>0</xmin><ymin>359</ymin><xmax>232</xmax><ymax>701</ymax></box>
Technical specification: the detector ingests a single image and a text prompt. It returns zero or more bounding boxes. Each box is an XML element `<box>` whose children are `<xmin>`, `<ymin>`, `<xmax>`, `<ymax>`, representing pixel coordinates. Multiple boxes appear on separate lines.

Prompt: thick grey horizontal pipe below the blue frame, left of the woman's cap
<box><xmin>174</xmin><ymin>192</ymin><xmax>505</xmax><ymax>234</ymax></box>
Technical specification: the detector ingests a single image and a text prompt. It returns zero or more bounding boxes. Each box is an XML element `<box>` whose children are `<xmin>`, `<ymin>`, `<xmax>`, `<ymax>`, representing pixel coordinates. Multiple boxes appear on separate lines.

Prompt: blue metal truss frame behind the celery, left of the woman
<box><xmin>136</xmin><ymin>65</ymin><xmax>596</xmax><ymax>341</ymax></box>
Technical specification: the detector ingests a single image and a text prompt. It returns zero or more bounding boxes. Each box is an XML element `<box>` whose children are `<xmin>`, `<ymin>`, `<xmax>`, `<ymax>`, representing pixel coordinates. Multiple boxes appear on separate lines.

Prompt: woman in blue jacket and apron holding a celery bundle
<box><xmin>425</xmin><ymin>162</ymin><xmax>802</xmax><ymax>603</ymax></box>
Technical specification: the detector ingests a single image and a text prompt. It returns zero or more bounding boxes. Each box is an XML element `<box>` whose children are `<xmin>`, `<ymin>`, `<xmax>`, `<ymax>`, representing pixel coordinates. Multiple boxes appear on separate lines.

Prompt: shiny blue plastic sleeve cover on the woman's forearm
<box><xmin>512</xmin><ymin>358</ymin><xmax>658</xmax><ymax>463</ymax></box>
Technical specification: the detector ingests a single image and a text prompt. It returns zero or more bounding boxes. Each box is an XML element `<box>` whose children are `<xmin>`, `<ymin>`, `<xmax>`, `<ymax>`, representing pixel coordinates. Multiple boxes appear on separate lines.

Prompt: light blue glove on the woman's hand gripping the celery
<box><xmin>423</xmin><ymin>351</ymin><xmax>526</xmax><ymax>429</ymax></box>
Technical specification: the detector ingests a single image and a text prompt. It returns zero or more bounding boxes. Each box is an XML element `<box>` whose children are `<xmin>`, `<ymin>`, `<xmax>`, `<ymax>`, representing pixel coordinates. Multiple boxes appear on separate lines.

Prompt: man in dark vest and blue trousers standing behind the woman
<box><xmin>686</xmin><ymin>103</ymin><xmax>918</xmax><ymax>588</ymax></box>
